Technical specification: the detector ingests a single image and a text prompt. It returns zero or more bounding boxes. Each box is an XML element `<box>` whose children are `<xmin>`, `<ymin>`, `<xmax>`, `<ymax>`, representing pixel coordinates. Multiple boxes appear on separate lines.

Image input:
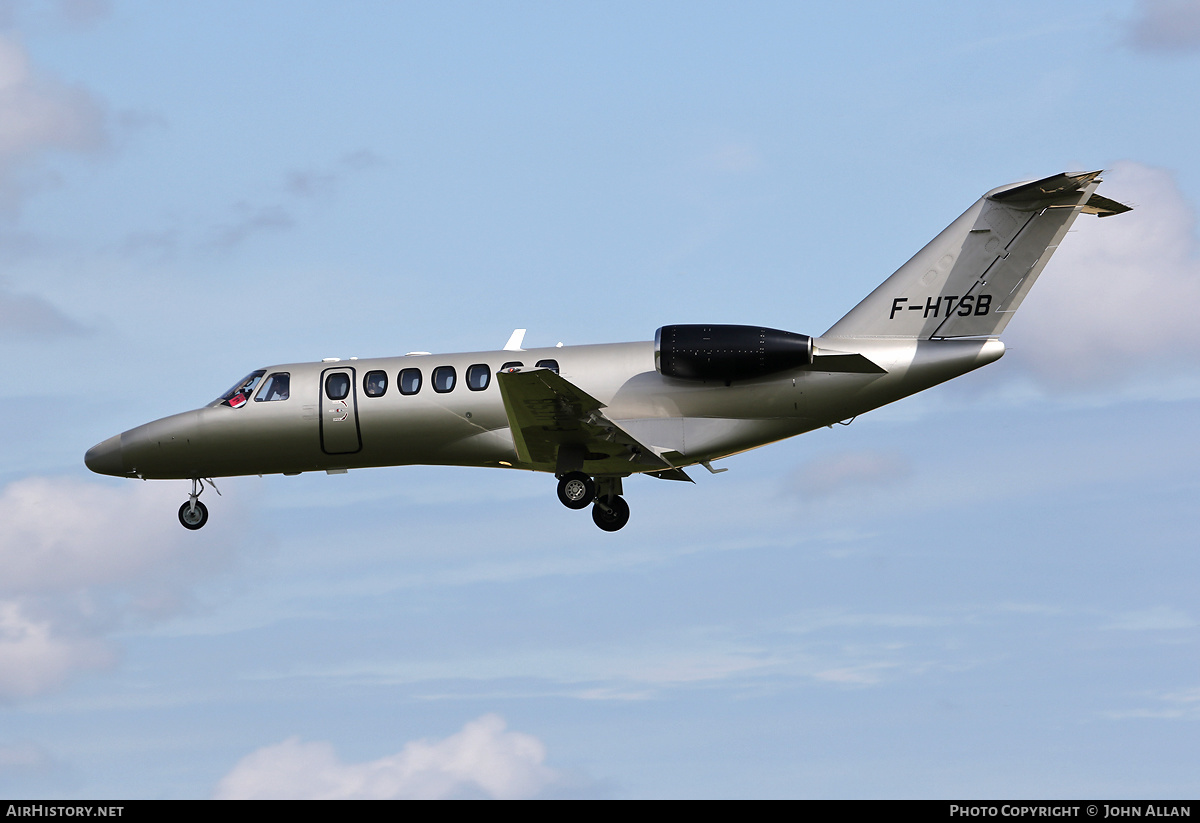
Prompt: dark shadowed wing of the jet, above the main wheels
<box><xmin>496</xmin><ymin>368</ymin><xmax>689</xmax><ymax>480</ymax></box>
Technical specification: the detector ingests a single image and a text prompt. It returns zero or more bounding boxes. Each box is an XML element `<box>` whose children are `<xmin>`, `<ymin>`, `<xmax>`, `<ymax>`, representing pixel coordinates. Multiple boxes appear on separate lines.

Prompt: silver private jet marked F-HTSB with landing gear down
<box><xmin>84</xmin><ymin>172</ymin><xmax>1129</xmax><ymax>531</ymax></box>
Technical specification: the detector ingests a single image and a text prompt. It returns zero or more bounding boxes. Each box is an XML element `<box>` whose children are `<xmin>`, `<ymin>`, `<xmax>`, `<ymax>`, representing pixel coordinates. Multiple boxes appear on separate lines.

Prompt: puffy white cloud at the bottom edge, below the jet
<box><xmin>216</xmin><ymin>714</ymin><xmax>559</xmax><ymax>800</ymax></box>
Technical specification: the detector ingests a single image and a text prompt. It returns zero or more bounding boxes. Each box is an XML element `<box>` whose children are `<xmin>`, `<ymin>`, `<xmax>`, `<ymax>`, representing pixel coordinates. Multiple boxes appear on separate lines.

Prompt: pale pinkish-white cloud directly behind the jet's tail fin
<box><xmin>1006</xmin><ymin>162</ymin><xmax>1200</xmax><ymax>388</ymax></box>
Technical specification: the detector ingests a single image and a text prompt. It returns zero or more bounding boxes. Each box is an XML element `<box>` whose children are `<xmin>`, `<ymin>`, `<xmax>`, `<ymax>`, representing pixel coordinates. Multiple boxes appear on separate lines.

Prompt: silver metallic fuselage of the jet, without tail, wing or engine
<box><xmin>86</xmin><ymin>338</ymin><xmax>1004</xmax><ymax>479</ymax></box>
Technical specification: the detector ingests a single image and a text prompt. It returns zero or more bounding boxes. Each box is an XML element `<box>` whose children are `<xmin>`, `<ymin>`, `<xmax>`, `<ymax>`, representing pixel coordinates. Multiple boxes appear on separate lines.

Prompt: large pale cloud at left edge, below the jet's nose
<box><xmin>0</xmin><ymin>477</ymin><xmax>238</xmax><ymax>699</ymax></box>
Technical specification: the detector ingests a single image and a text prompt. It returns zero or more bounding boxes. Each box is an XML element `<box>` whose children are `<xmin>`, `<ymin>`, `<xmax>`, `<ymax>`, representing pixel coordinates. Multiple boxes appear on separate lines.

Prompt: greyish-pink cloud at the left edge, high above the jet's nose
<box><xmin>0</xmin><ymin>35</ymin><xmax>108</xmax><ymax>211</ymax></box>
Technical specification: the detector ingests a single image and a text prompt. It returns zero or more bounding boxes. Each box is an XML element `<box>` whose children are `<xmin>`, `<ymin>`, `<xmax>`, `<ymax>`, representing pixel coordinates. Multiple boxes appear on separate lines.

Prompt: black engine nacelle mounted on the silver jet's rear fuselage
<box><xmin>654</xmin><ymin>325</ymin><xmax>812</xmax><ymax>383</ymax></box>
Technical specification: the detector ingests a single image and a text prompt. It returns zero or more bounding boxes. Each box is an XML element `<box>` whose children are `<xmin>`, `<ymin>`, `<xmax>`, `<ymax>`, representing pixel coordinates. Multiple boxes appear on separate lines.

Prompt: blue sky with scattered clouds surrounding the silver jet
<box><xmin>0</xmin><ymin>0</ymin><xmax>1200</xmax><ymax>798</ymax></box>
